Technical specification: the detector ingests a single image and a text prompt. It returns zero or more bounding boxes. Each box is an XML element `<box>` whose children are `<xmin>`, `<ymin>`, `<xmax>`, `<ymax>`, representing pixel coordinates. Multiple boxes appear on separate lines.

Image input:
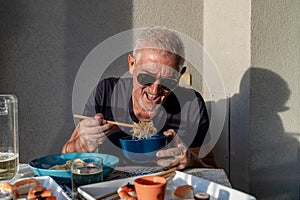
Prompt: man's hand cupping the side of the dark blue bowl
<box><xmin>156</xmin><ymin>129</ymin><xmax>211</xmax><ymax>170</ymax></box>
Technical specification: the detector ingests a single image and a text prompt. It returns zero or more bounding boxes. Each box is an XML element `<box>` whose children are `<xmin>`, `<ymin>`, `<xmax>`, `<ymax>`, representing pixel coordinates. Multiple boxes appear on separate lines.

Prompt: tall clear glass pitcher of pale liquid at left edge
<box><xmin>0</xmin><ymin>95</ymin><xmax>19</xmax><ymax>180</ymax></box>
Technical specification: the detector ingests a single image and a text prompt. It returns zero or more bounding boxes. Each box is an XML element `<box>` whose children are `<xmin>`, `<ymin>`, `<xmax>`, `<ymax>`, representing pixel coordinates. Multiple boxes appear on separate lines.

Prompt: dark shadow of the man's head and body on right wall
<box><xmin>232</xmin><ymin>68</ymin><xmax>300</xmax><ymax>199</ymax></box>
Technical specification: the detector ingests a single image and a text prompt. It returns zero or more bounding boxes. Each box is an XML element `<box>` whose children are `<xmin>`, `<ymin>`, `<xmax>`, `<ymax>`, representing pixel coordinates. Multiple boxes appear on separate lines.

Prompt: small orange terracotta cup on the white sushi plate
<box><xmin>134</xmin><ymin>176</ymin><xmax>167</xmax><ymax>200</ymax></box>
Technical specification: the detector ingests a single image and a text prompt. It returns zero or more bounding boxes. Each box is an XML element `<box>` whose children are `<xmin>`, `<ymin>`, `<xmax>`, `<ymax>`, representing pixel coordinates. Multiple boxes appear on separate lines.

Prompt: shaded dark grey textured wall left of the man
<box><xmin>0</xmin><ymin>0</ymin><xmax>132</xmax><ymax>162</ymax></box>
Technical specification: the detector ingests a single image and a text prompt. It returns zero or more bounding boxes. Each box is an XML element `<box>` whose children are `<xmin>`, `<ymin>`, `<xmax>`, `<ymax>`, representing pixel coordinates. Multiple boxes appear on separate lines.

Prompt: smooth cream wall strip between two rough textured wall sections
<box><xmin>203</xmin><ymin>0</ymin><xmax>251</xmax><ymax>190</ymax></box>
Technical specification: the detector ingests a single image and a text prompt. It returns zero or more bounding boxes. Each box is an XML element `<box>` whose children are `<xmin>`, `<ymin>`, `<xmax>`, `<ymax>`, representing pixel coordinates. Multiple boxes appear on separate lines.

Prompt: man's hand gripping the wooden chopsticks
<box><xmin>78</xmin><ymin>113</ymin><xmax>117</xmax><ymax>152</ymax></box>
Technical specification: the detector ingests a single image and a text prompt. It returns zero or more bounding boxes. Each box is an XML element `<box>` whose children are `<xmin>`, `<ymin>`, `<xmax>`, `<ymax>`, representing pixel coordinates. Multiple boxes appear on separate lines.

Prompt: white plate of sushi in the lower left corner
<box><xmin>12</xmin><ymin>176</ymin><xmax>71</xmax><ymax>200</ymax></box>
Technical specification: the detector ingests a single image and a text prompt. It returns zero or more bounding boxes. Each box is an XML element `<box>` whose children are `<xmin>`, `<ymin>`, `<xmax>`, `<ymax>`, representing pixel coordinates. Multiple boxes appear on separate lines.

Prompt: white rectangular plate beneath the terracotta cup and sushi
<box><xmin>78</xmin><ymin>171</ymin><xmax>256</xmax><ymax>200</ymax></box>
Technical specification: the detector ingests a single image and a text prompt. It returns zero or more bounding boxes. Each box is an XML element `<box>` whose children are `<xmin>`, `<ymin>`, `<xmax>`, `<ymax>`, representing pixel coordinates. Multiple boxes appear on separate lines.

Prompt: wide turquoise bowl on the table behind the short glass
<box><xmin>28</xmin><ymin>153</ymin><xmax>119</xmax><ymax>183</ymax></box>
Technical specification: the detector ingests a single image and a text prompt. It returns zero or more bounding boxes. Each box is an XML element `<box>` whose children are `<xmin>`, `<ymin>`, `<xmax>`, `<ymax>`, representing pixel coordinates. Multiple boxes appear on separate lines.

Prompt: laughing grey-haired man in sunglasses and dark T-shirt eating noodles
<box><xmin>62</xmin><ymin>27</ymin><xmax>215</xmax><ymax>169</ymax></box>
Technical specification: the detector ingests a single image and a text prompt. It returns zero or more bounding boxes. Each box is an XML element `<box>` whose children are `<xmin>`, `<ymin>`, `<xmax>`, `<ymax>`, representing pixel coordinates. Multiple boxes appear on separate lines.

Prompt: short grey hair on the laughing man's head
<box><xmin>133</xmin><ymin>27</ymin><xmax>184</xmax><ymax>70</ymax></box>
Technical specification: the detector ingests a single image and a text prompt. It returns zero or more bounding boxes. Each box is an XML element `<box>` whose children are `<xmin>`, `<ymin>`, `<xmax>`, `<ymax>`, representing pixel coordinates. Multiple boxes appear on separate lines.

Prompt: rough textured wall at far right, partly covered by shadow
<box><xmin>249</xmin><ymin>0</ymin><xmax>300</xmax><ymax>199</ymax></box>
